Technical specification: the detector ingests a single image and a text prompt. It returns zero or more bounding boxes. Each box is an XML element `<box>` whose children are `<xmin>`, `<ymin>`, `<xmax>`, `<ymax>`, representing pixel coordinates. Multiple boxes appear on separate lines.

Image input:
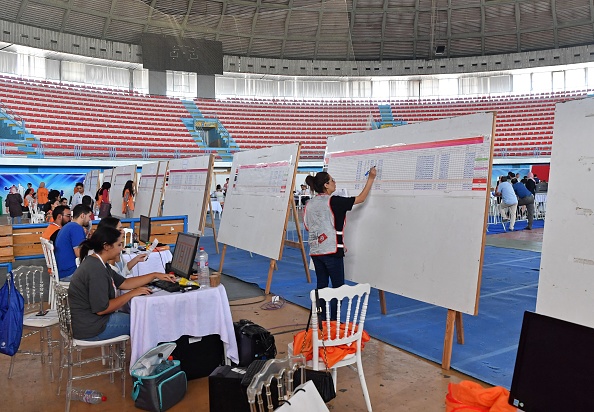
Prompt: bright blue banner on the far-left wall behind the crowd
<box><xmin>0</xmin><ymin>173</ymin><xmax>85</xmax><ymax>200</ymax></box>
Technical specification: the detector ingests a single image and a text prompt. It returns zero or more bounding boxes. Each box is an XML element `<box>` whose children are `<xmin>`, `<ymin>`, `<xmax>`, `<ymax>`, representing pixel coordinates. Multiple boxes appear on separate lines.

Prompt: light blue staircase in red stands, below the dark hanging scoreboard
<box><xmin>182</xmin><ymin>100</ymin><xmax>239</xmax><ymax>162</ymax></box>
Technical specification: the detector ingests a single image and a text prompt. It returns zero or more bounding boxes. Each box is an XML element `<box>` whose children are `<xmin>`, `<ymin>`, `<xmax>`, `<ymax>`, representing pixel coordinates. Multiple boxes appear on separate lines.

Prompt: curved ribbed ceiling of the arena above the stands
<box><xmin>0</xmin><ymin>0</ymin><xmax>594</xmax><ymax>60</ymax></box>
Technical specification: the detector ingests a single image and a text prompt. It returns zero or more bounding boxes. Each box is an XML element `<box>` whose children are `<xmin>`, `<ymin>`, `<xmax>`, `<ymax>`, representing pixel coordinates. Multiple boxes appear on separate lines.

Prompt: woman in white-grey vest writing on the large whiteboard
<box><xmin>303</xmin><ymin>166</ymin><xmax>377</xmax><ymax>320</ymax></box>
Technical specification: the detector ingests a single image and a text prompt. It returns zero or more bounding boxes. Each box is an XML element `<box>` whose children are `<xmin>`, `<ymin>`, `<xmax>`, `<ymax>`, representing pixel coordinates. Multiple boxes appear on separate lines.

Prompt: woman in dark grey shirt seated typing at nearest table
<box><xmin>68</xmin><ymin>226</ymin><xmax>175</xmax><ymax>341</ymax></box>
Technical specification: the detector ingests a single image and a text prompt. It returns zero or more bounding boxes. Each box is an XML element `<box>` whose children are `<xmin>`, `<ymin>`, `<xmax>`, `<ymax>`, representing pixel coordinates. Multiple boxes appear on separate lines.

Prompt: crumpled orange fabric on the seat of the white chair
<box><xmin>293</xmin><ymin>321</ymin><xmax>370</xmax><ymax>368</ymax></box>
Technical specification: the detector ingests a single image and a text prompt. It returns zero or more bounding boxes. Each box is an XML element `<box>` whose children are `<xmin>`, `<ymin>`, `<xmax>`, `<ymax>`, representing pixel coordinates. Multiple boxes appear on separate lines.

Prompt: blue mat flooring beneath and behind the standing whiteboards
<box><xmin>200</xmin><ymin>225</ymin><xmax>540</xmax><ymax>389</ymax></box>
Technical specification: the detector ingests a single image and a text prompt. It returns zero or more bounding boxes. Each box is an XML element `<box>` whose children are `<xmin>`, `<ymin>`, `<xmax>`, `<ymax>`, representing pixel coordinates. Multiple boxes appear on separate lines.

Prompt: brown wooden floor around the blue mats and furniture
<box><xmin>0</xmin><ymin>229</ymin><xmax>542</xmax><ymax>412</ymax></box>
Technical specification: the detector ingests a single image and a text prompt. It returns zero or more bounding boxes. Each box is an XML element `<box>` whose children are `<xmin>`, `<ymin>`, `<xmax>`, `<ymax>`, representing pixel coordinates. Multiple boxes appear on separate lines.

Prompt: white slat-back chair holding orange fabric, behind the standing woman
<box><xmin>288</xmin><ymin>283</ymin><xmax>372</xmax><ymax>411</ymax></box>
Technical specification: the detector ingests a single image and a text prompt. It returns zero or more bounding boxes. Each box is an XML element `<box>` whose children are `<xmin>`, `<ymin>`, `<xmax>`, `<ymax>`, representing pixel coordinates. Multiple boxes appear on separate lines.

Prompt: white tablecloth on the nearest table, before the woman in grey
<box><xmin>130</xmin><ymin>285</ymin><xmax>239</xmax><ymax>365</ymax></box>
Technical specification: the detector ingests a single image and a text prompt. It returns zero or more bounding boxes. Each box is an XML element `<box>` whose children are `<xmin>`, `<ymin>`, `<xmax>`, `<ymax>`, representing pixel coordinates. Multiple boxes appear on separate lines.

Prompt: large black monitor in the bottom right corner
<box><xmin>509</xmin><ymin>312</ymin><xmax>594</xmax><ymax>412</ymax></box>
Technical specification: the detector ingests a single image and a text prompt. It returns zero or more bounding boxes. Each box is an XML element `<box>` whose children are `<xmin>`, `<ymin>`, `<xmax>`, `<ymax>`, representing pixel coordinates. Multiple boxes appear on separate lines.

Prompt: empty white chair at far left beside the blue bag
<box><xmin>8</xmin><ymin>266</ymin><xmax>59</xmax><ymax>382</ymax></box>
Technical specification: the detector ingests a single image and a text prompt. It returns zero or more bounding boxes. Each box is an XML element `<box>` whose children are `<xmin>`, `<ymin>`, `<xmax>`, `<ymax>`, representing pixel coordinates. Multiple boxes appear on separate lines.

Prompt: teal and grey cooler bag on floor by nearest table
<box><xmin>130</xmin><ymin>343</ymin><xmax>188</xmax><ymax>412</ymax></box>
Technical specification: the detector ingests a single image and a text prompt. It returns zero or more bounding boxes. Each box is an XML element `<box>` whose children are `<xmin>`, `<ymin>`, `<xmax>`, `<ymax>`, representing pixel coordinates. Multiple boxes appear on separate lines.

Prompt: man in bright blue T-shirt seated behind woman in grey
<box><xmin>54</xmin><ymin>204</ymin><xmax>92</xmax><ymax>281</ymax></box>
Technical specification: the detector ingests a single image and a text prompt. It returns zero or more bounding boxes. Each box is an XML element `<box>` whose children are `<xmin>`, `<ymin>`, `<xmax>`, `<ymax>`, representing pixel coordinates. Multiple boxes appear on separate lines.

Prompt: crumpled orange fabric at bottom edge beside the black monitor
<box><xmin>445</xmin><ymin>381</ymin><xmax>517</xmax><ymax>412</ymax></box>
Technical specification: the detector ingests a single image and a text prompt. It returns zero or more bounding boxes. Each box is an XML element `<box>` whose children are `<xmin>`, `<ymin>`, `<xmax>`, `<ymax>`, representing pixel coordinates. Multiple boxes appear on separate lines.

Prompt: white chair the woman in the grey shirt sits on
<box><xmin>52</xmin><ymin>279</ymin><xmax>130</xmax><ymax>412</ymax></box>
